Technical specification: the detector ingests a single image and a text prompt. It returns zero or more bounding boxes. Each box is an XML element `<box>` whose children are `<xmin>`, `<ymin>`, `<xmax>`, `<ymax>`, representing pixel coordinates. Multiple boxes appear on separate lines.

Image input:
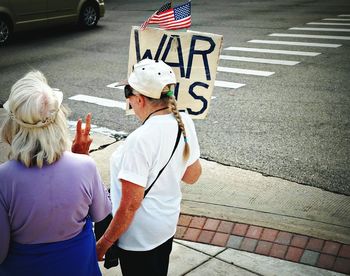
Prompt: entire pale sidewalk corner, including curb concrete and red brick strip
<box><xmin>0</xmin><ymin>109</ymin><xmax>350</xmax><ymax>276</ymax></box>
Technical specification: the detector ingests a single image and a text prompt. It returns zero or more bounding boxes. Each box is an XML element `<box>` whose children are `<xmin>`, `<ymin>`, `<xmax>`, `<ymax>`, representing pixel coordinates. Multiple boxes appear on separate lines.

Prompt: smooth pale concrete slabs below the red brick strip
<box><xmin>100</xmin><ymin>240</ymin><xmax>343</xmax><ymax>276</ymax></box>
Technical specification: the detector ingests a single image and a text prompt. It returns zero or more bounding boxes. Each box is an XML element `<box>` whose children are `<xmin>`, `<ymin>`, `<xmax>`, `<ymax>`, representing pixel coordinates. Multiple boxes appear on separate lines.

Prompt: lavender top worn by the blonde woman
<box><xmin>0</xmin><ymin>152</ymin><xmax>111</xmax><ymax>263</ymax></box>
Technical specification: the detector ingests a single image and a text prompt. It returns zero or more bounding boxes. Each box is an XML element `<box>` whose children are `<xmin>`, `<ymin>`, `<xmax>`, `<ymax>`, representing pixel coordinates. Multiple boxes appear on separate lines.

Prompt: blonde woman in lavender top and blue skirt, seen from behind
<box><xmin>0</xmin><ymin>71</ymin><xmax>111</xmax><ymax>276</ymax></box>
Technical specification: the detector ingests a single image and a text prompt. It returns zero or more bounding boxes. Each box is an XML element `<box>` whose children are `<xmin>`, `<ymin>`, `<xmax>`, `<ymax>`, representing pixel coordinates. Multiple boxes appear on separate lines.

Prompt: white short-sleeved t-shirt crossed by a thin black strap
<box><xmin>110</xmin><ymin>113</ymin><xmax>200</xmax><ymax>251</ymax></box>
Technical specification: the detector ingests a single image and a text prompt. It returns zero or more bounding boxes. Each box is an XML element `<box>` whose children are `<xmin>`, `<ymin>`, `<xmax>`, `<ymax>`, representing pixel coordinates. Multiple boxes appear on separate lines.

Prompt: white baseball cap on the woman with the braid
<box><xmin>127</xmin><ymin>59</ymin><xmax>176</xmax><ymax>99</ymax></box>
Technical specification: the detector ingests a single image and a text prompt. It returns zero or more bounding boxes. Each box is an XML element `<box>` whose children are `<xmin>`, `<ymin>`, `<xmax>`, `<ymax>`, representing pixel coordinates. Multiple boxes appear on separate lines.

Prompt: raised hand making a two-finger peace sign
<box><xmin>72</xmin><ymin>113</ymin><xmax>92</xmax><ymax>154</ymax></box>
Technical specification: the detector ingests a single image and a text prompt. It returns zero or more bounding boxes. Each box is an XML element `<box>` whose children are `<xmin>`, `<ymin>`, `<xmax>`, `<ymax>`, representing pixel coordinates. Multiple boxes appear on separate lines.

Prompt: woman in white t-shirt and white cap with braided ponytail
<box><xmin>97</xmin><ymin>59</ymin><xmax>202</xmax><ymax>276</ymax></box>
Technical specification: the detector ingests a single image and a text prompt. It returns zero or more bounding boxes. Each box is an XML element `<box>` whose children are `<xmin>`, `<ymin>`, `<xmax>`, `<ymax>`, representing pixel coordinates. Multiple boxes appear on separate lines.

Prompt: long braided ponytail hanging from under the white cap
<box><xmin>148</xmin><ymin>85</ymin><xmax>190</xmax><ymax>161</ymax></box>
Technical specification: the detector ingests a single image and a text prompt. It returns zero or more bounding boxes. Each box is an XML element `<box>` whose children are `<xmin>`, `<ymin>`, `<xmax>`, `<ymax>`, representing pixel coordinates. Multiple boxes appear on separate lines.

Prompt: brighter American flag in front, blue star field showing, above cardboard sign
<box><xmin>141</xmin><ymin>1</ymin><xmax>191</xmax><ymax>30</ymax></box>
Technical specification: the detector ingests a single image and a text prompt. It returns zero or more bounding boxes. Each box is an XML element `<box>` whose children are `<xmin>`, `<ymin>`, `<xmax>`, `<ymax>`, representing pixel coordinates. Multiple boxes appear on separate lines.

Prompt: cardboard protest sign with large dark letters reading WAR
<box><xmin>128</xmin><ymin>27</ymin><xmax>223</xmax><ymax>119</ymax></box>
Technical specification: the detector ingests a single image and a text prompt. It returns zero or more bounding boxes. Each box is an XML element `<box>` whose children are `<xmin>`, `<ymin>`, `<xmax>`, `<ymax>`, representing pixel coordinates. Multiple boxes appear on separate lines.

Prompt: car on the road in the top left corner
<box><xmin>0</xmin><ymin>0</ymin><xmax>105</xmax><ymax>45</ymax></box>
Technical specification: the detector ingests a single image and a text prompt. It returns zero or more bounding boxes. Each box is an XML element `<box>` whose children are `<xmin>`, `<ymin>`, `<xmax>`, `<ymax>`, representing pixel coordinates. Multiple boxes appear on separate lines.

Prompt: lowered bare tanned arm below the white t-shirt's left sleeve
<box><xmin>96</xmin><ymin>179</ymin><xmax>145</xmax><ymax>261</ymax></box>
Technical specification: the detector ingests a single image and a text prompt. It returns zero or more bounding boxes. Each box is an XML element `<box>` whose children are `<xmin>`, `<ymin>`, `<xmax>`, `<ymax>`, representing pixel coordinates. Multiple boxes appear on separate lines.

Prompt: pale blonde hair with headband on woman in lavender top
<box><xmin>1</xmin><ymin>71</ymin><xmax>68</xmax><ymax>168</ymax></box>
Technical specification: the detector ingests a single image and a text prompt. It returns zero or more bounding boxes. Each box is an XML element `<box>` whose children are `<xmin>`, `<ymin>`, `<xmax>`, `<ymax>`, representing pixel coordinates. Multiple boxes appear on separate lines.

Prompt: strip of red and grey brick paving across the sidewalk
<box><xmin>175</xmin><ymin>214</ymin><xmax>350</xmax><ymax>274</ymax></box>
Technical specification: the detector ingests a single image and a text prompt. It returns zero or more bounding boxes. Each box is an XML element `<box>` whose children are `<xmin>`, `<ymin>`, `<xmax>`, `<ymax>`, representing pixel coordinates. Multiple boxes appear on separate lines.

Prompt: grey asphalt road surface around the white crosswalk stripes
<box><xmin>0</xmin><ymin>0</ymin><xmax>350</xmax><ymax>195</ymax></box>
